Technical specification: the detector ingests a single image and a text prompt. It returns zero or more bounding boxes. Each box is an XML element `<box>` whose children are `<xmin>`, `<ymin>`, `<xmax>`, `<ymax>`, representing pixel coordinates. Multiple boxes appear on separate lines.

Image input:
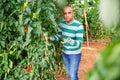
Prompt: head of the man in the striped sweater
<box><xmin>63</xmin><ymin>7</ymin><xmax>74</xmax><ymax>23</ymax></box>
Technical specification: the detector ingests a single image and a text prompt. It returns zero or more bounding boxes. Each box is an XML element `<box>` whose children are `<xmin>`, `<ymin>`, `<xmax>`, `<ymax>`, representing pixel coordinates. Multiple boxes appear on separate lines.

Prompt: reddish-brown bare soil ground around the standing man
<box><xmin>57</xmin><ymin>39</ymin><xmax>110</xmax><ymax>80</ymax></box>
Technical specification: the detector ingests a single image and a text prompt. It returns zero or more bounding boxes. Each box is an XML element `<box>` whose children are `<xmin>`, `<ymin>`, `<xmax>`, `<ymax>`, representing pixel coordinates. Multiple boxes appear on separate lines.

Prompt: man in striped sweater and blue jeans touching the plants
<box><xmin>50</xmin><ymin>6</ymin><xmax>84</xmax><ymax>80</ymax></box>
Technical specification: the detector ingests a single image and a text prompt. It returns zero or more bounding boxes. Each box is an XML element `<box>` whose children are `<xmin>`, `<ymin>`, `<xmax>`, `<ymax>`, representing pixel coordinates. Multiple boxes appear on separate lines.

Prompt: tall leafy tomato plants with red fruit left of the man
<box><xmin>0</xmin><ymin>0</ymin><xmax>63</xmax><ymax>80</ymax></box>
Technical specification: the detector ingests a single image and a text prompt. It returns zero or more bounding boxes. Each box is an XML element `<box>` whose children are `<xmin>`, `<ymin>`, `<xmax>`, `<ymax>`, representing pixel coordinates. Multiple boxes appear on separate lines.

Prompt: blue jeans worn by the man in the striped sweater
<box><xmin>63</xmin><ymin>53</ymin><xmax>81</xmax><ymax>80</ymax></box>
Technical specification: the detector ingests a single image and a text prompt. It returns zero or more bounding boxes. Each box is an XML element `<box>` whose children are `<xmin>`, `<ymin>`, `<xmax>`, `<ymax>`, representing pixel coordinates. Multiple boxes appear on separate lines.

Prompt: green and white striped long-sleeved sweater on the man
<box><xmin>51</xmin><ymin>20</ymin><xmax>84</xmax><ymax>54</ymax></box>
